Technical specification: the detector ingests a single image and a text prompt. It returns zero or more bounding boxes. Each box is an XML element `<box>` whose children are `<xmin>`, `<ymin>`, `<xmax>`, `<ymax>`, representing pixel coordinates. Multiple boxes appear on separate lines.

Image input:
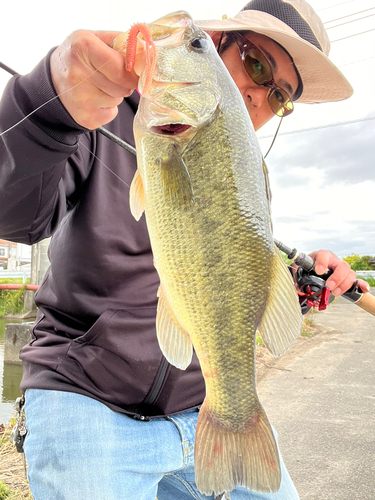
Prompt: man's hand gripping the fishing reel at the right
<box><xmin>310</xmin><ymin>250</ymin><xmax>370</xmax><ymax>296</ymax></box>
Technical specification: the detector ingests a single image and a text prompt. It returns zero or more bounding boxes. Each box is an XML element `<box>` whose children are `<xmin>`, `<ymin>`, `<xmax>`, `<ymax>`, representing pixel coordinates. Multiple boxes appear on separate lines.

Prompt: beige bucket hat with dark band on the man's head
<box><xmin>195</xmin><ymin>0</ymin><xmax>353</xmax><ymax>103</ymax></box>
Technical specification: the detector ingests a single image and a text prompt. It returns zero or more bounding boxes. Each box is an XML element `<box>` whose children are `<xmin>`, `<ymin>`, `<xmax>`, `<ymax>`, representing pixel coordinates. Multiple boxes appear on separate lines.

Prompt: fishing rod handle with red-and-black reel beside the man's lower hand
<box><xmin>274</xmin><ymin>239</ymin><xmax>375</xmax><ymax>316</ymax></box>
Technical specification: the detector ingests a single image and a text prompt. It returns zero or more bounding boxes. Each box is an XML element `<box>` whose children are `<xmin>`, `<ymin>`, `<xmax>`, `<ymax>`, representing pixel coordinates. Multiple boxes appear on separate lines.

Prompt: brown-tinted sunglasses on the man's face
<box><xmin>231</xmin><ymin>31</ymin><xmax>294</xmax><ymax>117</ymax></box>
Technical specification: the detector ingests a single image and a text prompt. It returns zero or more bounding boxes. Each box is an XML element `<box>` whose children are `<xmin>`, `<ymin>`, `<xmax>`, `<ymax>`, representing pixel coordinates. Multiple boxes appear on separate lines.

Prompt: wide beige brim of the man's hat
<box><xmin>194</xmin><ymin>10</ymin><xmax>353</xmax><ymax>104</ymax></box>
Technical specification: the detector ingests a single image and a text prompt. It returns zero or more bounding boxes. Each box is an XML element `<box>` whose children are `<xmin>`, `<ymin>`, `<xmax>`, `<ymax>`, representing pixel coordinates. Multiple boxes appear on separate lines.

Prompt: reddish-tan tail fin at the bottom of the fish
<box><xmin>195</xmin><ymin>400</ymin><xmax>281</xmax><ymax>498</ymax></box>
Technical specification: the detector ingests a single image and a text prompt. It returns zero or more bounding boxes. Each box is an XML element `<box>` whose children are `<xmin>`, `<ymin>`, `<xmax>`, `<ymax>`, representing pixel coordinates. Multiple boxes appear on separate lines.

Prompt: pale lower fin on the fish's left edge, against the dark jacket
<box><xmin>156</xmin><ymin>286</ymin><xmax>193</xmax><ymax>370</ymax></box>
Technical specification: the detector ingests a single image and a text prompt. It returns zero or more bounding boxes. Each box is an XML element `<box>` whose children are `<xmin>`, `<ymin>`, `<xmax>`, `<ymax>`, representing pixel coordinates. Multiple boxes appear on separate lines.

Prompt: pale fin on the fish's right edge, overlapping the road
<box><xmin>258</xmin><ymin>247</ymin><xmax>303</xmax><ymax>356</ymax></box>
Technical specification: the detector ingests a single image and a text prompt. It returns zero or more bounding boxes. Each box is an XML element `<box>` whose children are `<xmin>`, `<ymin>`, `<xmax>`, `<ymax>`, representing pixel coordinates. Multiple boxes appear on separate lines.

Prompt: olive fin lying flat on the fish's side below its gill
<box><xmin>156</xmin><ymin>143</ymin><xmax>194</xmax><ymax>206</ymax></box>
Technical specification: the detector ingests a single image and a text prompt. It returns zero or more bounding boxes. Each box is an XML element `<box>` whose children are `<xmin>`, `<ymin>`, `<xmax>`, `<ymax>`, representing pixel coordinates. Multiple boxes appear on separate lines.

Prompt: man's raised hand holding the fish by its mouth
<box><xmin>51</xmin><ymin>30</ymin><xmax>138</xmax><ymax>130</ymax></box>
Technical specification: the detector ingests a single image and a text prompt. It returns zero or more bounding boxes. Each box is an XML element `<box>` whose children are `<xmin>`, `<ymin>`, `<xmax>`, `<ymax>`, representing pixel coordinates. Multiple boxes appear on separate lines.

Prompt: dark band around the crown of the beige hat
<box><xmin>242</xmin><ymin>0</ymin><xmax>323</xmax><ymax>52</ymax></box>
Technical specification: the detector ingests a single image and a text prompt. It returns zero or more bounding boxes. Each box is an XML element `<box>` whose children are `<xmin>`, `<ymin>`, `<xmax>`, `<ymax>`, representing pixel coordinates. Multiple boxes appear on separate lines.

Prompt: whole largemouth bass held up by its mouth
<box><xmin>114</xmin><ymin>11</ymin><xmax>302</xmax><ymax>498</ymax></box>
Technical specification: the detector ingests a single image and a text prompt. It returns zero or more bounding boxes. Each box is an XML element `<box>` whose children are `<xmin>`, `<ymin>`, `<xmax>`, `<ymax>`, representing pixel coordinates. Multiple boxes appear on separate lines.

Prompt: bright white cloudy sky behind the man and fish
<box><xmin>0</xmin><ymin>0</ymin><xmax>375</xmax><ymax>257</ymax></box>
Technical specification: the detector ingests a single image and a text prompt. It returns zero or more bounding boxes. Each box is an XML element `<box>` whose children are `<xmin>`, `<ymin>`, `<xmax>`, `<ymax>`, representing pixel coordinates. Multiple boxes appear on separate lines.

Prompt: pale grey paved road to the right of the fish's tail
<box><xmin>258</xmin><ymin>289</ymin><xmax>375</xmax><ymax>500</ymax></box>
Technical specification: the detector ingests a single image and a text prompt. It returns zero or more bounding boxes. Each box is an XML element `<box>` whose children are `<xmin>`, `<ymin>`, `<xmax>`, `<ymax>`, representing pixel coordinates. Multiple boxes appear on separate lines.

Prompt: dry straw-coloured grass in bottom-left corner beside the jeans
<box><xmin>0</xmin><ymin>419</ymin><xmax>33</xmax><ymax>500</ymax></box>
